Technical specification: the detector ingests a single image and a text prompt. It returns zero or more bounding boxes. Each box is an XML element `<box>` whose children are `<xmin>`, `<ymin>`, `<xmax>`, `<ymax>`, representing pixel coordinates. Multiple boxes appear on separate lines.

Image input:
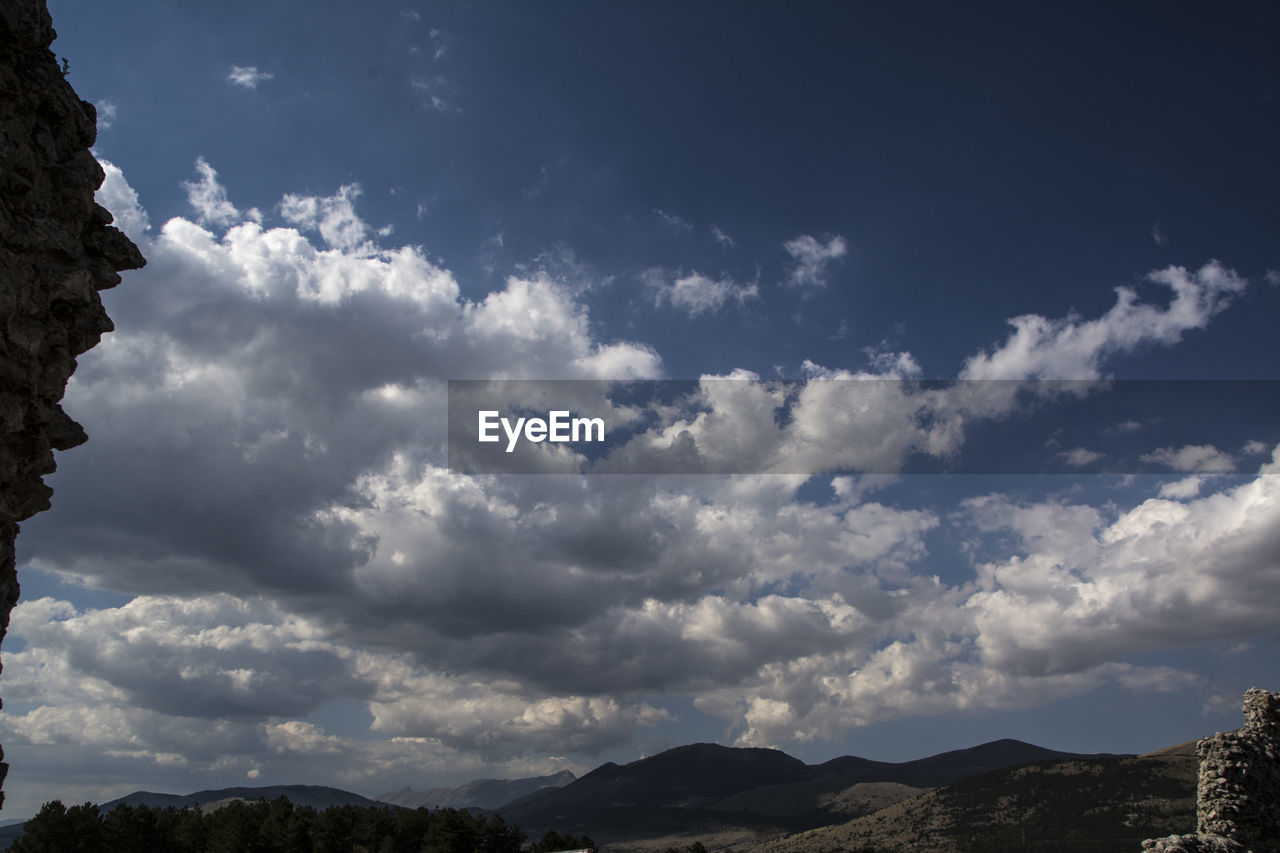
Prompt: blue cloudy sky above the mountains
<box><xmin>0</xmin><ymin>0</ymin><xmax>1280</xmax><ymax>817</ymax></box>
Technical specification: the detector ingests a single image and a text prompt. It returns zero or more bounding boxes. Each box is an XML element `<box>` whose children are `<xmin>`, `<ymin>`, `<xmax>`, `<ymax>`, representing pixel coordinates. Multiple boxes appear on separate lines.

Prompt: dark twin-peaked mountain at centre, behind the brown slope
<box><xmin>497</xmin><ymin>739</ymin><xmax>1116</xmax><ymax>838</ymax></box>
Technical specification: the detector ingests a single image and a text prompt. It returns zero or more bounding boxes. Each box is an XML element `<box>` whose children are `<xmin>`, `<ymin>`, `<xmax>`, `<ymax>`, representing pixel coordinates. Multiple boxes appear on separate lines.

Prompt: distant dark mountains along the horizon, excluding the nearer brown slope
<box><xmin>0</xmin><ymin>739</ymin><xmax>1131</xmax><ymax>849</ymax></box>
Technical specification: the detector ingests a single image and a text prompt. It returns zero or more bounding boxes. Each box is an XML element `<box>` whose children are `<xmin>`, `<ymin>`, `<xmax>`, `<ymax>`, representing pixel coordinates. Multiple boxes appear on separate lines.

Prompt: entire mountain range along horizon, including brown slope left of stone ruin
<box><xmin>0</xmin><ymin>739</ymin><xmax>1197</xmax><ymax>853</ymax></box>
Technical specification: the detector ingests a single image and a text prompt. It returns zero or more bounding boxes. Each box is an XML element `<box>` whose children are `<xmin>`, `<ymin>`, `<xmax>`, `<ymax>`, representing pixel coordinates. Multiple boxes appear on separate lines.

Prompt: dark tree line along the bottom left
<box><xmin>9</xmin><ymin>797</ymin><xmax>595</xmax><ymax>853</ymax></box>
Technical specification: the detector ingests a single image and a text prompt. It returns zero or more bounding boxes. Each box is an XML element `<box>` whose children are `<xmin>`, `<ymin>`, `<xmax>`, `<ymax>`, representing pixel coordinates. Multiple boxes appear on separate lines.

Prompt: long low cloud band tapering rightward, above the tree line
<box><xmin>6</xmin><ymin>594</ymin><xmax>666</xmax><ymax>762</ymax></box>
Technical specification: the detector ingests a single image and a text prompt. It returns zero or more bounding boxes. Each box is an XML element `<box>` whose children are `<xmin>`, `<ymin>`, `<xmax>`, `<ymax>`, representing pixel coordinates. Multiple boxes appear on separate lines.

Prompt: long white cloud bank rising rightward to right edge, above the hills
<box><xmin>698</xmin><ymin>448</ymin><xmax>1280</xmax><ymax>745</ymax></box>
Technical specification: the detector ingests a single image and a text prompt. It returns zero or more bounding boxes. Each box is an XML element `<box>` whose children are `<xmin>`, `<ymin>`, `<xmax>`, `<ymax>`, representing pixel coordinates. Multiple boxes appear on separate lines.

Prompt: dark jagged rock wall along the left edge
<box><xmin>0</xmin><ymin>0</ymin><xmax>146</xmax><ymax>803</ymax></box>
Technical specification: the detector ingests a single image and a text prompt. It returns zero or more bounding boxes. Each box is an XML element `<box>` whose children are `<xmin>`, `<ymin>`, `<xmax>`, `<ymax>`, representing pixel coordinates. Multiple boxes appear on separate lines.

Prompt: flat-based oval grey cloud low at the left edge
<box><xmin>9</xmin><ymin>596</ymin><xmax>372</xmax><ymax>720</ymax></box>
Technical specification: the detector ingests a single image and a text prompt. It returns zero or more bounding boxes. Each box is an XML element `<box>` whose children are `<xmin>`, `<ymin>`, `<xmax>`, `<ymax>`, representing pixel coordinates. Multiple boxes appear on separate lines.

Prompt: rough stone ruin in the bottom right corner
<box><xmin>1142</xmin><ymin>689</ymin><xmax>1280</xmax><ymax>853</ymax></box>
